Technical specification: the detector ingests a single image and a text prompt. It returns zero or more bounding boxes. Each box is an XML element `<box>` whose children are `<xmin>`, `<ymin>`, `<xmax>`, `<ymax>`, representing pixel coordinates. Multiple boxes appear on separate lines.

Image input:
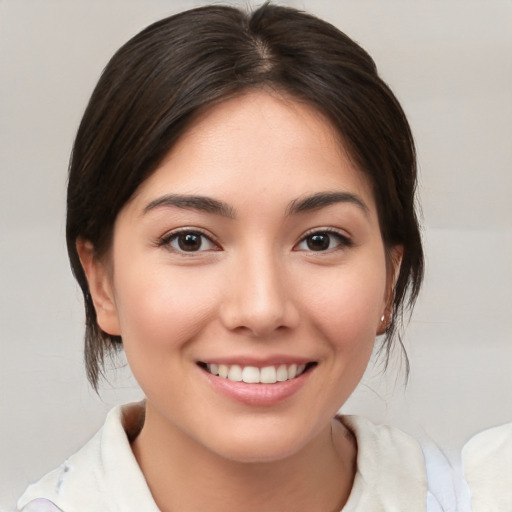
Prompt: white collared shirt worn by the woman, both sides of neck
<box><xmin>18</xmin><ymin>404</ymin><xmax>427</xmax><ymax>512</ymax></box>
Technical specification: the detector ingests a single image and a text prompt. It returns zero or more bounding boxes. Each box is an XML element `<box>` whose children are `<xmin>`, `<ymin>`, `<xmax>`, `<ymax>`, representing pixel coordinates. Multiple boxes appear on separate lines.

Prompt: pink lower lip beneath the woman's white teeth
<box><xmin>202</xmin><ymin>368</ymin><xmax>313</xmax><ymax>407</ymax></box>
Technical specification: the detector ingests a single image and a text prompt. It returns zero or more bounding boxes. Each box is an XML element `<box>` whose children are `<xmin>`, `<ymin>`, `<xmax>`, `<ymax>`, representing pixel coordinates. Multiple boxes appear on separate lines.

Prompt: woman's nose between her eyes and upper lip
<box><xmin>220</xmin><ymin>253</ymin><xmax>300</xmax><ymax>338</ymax></box>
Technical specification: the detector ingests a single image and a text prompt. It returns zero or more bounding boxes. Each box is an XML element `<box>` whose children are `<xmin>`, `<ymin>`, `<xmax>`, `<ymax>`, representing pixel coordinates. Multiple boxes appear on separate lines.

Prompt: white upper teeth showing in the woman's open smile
<box><xmin>198</xmin><ymin>362</ymin><xmax>316</xmax><ymax>384</ymax></box>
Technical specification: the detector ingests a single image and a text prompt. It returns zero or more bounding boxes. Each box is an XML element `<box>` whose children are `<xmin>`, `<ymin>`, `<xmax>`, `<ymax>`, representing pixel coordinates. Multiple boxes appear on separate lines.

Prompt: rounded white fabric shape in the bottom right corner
<box><xmin>462</xmin><ymin>423</ymin><xmax>512</xmax><ymax>512</ymax></box>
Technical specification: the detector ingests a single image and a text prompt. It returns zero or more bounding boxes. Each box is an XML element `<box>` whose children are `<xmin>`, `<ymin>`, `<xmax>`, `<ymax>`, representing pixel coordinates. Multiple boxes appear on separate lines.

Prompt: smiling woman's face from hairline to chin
<box><xmin>89</xmin><ymin>92</ymin><xmax>398</xmax><ymax>461</ymax></box>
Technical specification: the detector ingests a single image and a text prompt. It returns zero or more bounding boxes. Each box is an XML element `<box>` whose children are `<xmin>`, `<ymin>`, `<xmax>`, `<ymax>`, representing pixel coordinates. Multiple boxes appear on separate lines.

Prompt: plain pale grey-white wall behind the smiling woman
<box><xmin>0</xmin><ymin>0</ymin><xmax>512</xmax><ymax>508</ymax></box>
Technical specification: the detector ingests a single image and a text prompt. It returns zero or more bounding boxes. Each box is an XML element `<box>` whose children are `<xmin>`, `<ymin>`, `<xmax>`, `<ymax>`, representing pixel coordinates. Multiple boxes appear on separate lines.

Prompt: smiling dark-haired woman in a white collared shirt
<box><xmin>18</xmin><ymin>5</ymin><xmax>427</xmax><ymax>512</ymax></box>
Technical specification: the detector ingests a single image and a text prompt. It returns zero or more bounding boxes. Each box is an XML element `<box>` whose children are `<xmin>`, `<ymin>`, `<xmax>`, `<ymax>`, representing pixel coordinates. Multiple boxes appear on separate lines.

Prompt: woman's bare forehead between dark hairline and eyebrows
<box><xmin>128</xmin><ymin>91</ymin><xmax>373</xmax><ymax>212</ymax></box>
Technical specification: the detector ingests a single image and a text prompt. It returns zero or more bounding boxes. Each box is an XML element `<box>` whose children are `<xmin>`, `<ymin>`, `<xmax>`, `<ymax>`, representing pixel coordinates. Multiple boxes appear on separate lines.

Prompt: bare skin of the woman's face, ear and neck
<box><xmin>77</xmin><ymin>91</ymin><xmax>400</xmax><ymax>512</ymax></box>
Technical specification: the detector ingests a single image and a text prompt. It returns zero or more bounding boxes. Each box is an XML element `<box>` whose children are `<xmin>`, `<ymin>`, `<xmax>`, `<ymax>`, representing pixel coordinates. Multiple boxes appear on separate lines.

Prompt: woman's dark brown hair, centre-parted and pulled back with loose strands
<box><xmin>66</xmin><ymin>4</ymin><xmax>423</xmax><ymax>389</ymax></box>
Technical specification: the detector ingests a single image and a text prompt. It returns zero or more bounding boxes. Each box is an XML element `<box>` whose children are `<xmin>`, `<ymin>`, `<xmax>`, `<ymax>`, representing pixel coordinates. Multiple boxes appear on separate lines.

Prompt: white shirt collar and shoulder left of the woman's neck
<box><xmin>18</xmin><ymin>404</ymin><xmax>158</xmax><ymax>512</ymax></box>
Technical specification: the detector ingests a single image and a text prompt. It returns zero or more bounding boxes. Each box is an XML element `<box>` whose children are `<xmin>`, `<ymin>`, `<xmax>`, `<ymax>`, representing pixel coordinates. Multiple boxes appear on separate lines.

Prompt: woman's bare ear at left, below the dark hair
<box><xmin>76</xmin><ymin>239</ymin><xmax>121</xmax><ymax>336</ymax></box>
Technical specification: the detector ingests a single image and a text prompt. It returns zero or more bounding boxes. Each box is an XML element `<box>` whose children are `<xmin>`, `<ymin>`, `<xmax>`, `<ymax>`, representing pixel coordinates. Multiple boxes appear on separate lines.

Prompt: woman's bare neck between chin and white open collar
<box><xmin>133</xmin><ymin>408</ymin><xmax>356</xmax><ymax>512</ymax></box>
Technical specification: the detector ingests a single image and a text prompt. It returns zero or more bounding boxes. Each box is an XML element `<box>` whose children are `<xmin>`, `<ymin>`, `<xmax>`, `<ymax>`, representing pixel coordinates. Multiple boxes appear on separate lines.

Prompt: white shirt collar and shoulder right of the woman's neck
<box><xmin>339</xmin><ymin>416</ymin><xmax>428</xmax><ymax>512</ymax></box>
